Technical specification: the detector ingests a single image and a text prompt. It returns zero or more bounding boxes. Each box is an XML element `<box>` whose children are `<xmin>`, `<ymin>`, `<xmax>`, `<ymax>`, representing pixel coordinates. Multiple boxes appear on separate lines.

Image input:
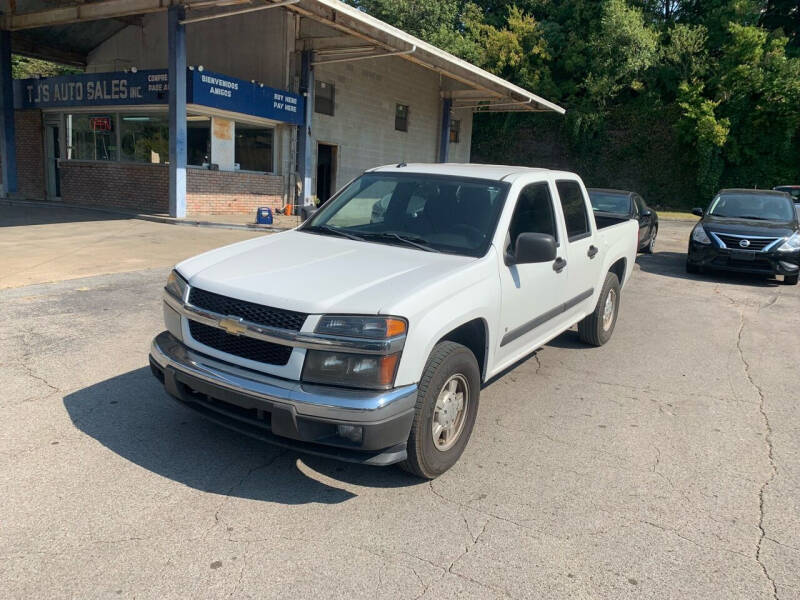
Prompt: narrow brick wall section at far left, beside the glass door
<box><xmin>0</xmin><ymin>110</ymin><xmax>46</xmax><ymax>200</ymax></box>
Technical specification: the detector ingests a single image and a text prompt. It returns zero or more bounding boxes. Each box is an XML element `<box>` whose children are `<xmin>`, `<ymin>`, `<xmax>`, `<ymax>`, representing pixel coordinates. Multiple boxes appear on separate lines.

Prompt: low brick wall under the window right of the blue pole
<box><xmin>186</xmin><ymin>169</ymin><xmax>283</xmax><ymax>215</ymax></box>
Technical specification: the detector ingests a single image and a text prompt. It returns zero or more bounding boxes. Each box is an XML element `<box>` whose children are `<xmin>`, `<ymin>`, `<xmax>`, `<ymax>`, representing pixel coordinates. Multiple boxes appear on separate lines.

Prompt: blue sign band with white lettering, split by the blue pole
<box><xmin>14</xmin><ymin>69</ymin><xmax>305</xmax><ymax>125</ymax></box>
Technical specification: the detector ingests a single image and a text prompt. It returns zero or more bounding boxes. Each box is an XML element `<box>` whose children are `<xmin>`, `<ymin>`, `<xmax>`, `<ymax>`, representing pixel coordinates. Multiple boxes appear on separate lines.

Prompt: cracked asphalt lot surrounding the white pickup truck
<box><xmin>0</xmin><ymin>209</ymin><xmax>800</xmax><ymax>600</ymax></box>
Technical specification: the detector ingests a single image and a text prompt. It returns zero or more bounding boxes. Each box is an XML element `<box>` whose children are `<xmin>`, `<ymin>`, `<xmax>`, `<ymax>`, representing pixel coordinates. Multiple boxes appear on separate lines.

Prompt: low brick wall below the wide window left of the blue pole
<box><xmin>59</xmin><ymin>161</ymin><xmax>169</xmax><ymax>213</ymax></box>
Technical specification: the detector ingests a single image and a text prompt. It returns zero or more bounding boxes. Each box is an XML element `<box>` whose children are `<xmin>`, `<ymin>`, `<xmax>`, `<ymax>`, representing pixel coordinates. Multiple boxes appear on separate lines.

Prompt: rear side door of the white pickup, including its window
<box><xmin>556</xmin><ymin>179</ymin><xmax>602</xmax><ymax>324</ymax></box>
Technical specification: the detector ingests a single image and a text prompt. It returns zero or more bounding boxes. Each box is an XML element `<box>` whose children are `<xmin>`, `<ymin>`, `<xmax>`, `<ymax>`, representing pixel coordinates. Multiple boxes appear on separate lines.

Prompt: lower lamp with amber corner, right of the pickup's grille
<box><xmin>303</xmin><ymin>350</ymin><xmax>400</xmax><ymax>390</ymax></box>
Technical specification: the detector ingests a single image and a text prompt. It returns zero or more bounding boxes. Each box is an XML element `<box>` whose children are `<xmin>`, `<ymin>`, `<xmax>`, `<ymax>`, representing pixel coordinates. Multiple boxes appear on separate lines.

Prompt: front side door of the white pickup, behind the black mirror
<box><xmin>497</xmin><ymin>182</ymin><xmax>568</xmax><ymax>368</ymax></box>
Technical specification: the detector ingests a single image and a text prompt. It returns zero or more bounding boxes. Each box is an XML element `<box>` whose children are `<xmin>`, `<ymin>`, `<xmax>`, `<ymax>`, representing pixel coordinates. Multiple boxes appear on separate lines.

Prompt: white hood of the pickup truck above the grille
<box><xmin>177</xmin><ymin>231</ymin><xmax>476</xmax><ymax>316</ymax></box>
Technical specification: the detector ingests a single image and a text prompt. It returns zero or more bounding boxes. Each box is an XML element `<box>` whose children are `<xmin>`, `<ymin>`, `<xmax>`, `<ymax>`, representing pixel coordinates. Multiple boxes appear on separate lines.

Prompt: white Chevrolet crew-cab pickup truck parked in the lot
<box><xmin>150</xmin><ymin>164</ymin><xmax>638</xmax><ymax>478</ymax></box>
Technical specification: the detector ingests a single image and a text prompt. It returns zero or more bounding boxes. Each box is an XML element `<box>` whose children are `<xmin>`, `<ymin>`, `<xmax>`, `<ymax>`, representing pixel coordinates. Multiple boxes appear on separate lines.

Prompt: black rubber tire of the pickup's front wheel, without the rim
<box><xmin>400</xmin><ymin>342</ymin><xmax>481</xmax><ymax>479</ymax></box>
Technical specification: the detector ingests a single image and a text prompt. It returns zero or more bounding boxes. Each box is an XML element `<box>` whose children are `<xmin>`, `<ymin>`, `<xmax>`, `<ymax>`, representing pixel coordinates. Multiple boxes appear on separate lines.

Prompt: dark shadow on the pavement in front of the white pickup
<box><xmin>64</xmin><ymin>368</ymin><xmax>423</xmax><ymax>505</ymax></box>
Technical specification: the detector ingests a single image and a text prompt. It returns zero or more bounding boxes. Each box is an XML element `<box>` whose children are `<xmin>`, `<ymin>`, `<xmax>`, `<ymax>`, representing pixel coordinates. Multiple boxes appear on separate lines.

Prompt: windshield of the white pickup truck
<box><xmin>301</xmin><ymin>172</ymin><xmax>509</xmax><ymax>257</ymax></box>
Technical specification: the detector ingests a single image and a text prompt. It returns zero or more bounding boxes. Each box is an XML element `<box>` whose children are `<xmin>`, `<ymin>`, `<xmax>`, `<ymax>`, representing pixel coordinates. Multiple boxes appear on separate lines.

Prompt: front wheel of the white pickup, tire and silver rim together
<box><xmin>400</xmin><ymin>342</ymin><xmax>481</xmax><ymax>479</ymax></box>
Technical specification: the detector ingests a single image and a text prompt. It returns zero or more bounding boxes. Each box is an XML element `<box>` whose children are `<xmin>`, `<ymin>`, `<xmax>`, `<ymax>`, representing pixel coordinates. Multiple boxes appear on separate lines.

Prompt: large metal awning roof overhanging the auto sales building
<box><xmin>0</xmin><ymin>0</ymin><xmax>566</xmax><ymax>114</ymax></box>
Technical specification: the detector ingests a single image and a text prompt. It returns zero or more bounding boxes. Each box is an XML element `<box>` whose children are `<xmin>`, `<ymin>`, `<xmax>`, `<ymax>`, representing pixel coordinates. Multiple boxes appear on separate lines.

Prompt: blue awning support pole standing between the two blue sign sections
<box><xmin>167</xmin><ymin>5</ymin><xmax>188</xmax><ymax>219</ymax></box>
